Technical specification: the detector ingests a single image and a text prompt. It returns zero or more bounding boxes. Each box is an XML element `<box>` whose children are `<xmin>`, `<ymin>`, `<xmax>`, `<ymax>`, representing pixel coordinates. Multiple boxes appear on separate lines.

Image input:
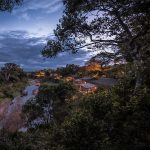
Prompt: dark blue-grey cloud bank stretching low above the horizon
<box><xmin>0</xmin><ymin>31</ymin><xmax>90</xmax><ymax>71</ymax></box>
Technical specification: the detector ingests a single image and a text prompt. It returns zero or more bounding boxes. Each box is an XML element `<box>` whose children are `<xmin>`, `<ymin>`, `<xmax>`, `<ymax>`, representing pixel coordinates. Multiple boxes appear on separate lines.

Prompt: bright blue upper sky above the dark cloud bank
<box><xmin>0</xmin><ymin>0</ymin><xmax>63</xmax><ymax>39</ymax></box>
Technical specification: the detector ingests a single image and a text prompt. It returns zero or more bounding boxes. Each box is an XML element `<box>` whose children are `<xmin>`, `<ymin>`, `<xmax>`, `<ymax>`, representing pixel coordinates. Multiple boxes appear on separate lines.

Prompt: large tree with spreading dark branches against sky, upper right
<box><xmin>42</xmin><ymin>0</ymin><xmax>150</xmax><ymax>90</ymax></box>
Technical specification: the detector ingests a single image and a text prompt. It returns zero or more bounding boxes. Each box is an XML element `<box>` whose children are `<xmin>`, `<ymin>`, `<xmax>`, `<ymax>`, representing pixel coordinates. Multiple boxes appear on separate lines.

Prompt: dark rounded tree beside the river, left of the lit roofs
<box><xmin>23</xmin><ymin>83</ymin><xmax>76</xmax><ymax>127</ymax></box>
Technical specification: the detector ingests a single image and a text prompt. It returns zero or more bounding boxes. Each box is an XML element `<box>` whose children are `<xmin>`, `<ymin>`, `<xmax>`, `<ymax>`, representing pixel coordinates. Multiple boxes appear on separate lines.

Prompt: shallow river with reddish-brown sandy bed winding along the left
<box><xmin>0</xmin><ymin>81</ymin><xmax>39</xmax><ymax>131</ymax></box>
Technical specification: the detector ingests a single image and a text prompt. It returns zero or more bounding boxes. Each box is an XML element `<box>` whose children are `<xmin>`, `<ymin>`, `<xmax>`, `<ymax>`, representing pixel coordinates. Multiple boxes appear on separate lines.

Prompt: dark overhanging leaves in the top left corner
<box><xmin>0</xmin><ymin>0</ymin><xmax>22</xmax><ymax>11</ymax></box>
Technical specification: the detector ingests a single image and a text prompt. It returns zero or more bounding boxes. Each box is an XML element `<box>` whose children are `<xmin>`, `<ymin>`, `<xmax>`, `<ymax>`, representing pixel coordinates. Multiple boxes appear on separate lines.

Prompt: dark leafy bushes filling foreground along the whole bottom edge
<box><xmin>1</xmin><ymin>80</ymin><xmax>150</xmax><ymax>150</ymax></box>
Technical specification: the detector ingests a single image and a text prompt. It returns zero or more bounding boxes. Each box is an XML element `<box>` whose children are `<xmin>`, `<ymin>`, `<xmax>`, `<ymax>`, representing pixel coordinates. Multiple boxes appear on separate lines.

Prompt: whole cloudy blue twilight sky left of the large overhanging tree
<box><xmin>0</xmin><ymin>0</ymin><xmax>92</xmax><ymax>71</ymax></box>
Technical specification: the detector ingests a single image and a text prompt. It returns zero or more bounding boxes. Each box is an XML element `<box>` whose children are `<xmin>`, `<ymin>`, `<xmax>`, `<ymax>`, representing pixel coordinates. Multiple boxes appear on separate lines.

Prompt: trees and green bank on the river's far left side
<box><xmin>0</xmin><ymin>63</ymin><xmax>27</xmax><ymax>101</ymax></box>
